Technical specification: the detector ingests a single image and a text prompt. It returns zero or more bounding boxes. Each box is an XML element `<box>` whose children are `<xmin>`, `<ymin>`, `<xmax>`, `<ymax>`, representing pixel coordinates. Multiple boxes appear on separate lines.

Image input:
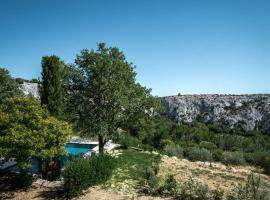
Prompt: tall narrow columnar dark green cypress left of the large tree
<box><xmin>41</xmin><ymin>55</ymin><xmax>63</xmax><ymax>117</ymax></box>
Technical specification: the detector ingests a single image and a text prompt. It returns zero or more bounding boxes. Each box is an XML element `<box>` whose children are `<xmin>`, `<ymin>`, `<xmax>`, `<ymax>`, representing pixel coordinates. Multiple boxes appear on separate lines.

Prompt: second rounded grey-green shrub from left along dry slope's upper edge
<box><xmin>188</xmin><ymin>147</ymin><xmax>213</xmax><ymax>161</ymax></box>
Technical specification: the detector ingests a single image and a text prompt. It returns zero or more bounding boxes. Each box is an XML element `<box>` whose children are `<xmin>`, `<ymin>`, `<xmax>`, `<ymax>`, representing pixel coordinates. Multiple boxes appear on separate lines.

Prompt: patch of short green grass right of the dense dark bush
<box><xmin>103</xmin><ymin>149</ymin><xmax>160</xmax><ymax>193</ymax></box>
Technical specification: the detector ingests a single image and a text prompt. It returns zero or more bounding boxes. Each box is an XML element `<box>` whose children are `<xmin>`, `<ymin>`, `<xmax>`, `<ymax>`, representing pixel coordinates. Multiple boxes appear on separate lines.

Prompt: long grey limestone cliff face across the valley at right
<box><xmin>161</xmin><ymin>94</ymin><xmax>270</xmax><ymax>131</ymax></box>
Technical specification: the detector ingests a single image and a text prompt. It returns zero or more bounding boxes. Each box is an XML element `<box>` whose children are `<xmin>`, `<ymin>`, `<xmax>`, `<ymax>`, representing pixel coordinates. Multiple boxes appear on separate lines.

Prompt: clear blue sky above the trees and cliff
<box><xmin>0</xmin><ymin>0</ymin><xmax>270</xmax><ymax>96</ymax></box>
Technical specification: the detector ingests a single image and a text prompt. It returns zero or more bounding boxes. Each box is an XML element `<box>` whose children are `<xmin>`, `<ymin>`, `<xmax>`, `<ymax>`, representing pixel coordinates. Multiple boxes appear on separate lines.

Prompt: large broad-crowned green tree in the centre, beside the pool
<box><xmin>75</xmin><ymin>43</ymin><xmax>159</xmax><ymax>155</ymax></box>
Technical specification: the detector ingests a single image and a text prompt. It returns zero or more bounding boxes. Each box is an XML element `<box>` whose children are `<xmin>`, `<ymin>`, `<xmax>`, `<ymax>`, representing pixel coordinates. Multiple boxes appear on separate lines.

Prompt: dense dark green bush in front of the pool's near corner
<box><xmin>62</xmin><ymin>155</ymin><xmax>115</xmax><ymax>197</ymax></box>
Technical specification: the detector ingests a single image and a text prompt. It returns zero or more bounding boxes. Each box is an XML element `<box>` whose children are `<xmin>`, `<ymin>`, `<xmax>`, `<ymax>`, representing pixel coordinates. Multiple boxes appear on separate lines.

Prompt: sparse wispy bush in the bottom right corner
<box><xmin>228</xmin><ymin>173</ymin><xmax>268</xmax><ymax>200</ymax></box>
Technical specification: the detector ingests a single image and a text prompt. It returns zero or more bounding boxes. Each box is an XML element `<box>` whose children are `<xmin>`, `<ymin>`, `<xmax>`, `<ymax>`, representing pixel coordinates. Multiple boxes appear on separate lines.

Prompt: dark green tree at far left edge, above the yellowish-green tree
<box><xmin>0</xmin><ymin>68</ymin><xmax>22</xmax><ymax>104</ymax></box>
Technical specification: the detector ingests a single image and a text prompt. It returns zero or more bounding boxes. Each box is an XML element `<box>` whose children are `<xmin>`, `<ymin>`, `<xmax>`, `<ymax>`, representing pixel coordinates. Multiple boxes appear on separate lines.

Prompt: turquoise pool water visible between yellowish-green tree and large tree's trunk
<box><xmin>65</xmin><ymin>143</ymin><xmax>97</xmax><ymax>155</ymax></box>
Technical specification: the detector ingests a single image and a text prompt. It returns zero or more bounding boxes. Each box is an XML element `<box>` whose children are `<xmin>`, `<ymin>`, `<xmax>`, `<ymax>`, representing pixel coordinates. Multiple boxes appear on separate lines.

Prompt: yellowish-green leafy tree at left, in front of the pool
<box><xmin>0</xmin><ymin>97</ymin><xmax>71</xmax><ymax>179</ymax></box>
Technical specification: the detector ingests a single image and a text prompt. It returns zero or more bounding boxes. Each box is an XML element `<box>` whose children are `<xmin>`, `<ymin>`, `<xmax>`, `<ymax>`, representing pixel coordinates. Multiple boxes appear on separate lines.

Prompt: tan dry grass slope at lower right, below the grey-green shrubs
<box><xmin>159</xmin><ymin>156</ymin><xmax>270</xmax><ymax>195</ymax></box>
